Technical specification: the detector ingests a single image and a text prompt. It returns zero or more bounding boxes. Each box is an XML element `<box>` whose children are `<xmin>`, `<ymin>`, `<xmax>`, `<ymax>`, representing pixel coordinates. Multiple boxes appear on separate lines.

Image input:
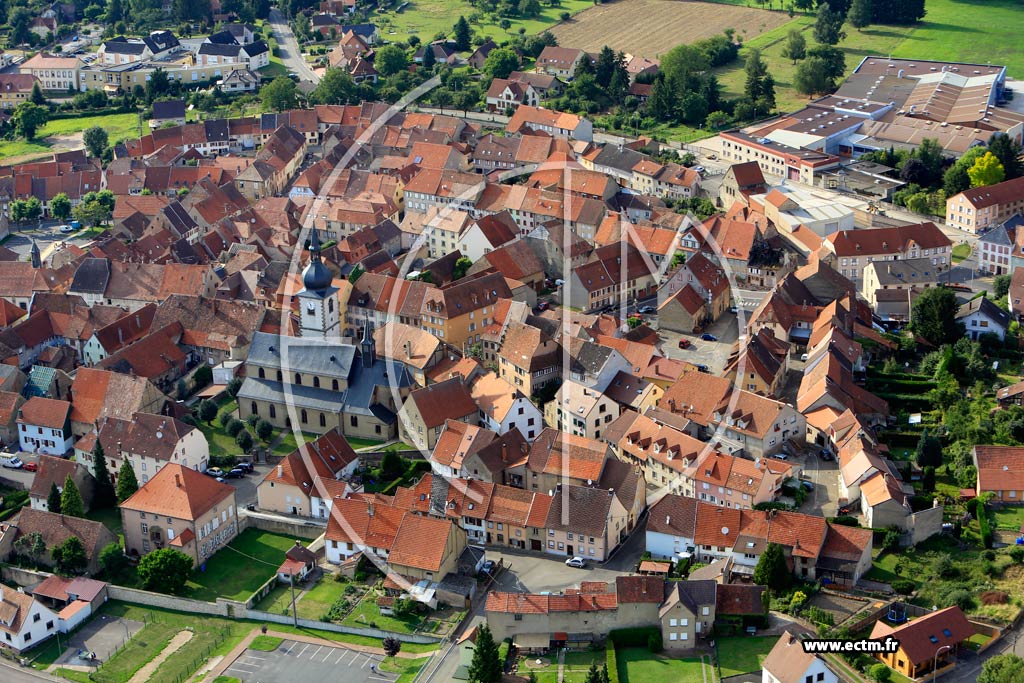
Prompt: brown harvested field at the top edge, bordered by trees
<box><xmin>550</xmin><ymin>0</ymin><xmax>791</xmax><ymax>58</ymax></box>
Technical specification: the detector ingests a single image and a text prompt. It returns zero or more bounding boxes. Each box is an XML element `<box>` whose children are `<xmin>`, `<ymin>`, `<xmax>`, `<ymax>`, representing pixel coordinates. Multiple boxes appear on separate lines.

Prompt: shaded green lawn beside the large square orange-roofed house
<box><xmin>187</xmin><ymin>528</ymin><xmax>295</xmax><ymax>602</ymax></box>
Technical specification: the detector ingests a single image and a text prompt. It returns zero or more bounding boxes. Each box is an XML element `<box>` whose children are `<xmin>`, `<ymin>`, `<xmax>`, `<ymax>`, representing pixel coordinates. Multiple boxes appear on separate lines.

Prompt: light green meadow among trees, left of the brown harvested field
<box><xmin>370</xmin><ymin>0</ymin><xmax>594</xmax><ymax>43</ymax></box>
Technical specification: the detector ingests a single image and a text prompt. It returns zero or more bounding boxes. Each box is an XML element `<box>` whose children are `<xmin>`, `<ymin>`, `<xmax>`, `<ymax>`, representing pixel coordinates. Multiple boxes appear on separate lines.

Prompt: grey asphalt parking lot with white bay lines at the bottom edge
<box><xmin>224</xmin><ymin>640</ymin><xmax>397</xmax><ymax>683</ymax></box>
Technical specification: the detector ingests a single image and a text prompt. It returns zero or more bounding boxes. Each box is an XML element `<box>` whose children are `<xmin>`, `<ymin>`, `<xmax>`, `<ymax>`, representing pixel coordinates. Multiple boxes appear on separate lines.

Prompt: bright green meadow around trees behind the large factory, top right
<box><xmin>716</xmin><ymin>0</ymin><xmax>1024</xmax><ymax>112</ymax></box>
